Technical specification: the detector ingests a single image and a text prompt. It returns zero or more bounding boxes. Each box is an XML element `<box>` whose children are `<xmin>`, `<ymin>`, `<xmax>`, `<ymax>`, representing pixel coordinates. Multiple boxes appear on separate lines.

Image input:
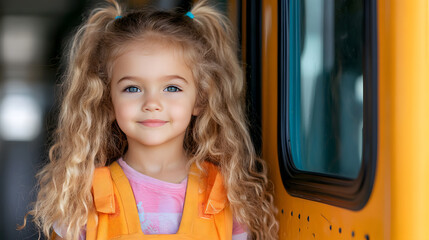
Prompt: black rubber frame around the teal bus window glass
<box><xmin>277</xmin><ymin>0</ymin><xmax>378</xmax><ymax>211</ymax></box>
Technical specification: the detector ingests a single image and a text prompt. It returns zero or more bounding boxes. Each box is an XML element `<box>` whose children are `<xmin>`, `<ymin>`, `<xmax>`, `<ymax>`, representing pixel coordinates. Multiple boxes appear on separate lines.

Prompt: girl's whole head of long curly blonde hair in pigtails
<box><xmin>30</xmin><ymin>0</ymin><xmax>278</xmax><ymax>239</ymax></box>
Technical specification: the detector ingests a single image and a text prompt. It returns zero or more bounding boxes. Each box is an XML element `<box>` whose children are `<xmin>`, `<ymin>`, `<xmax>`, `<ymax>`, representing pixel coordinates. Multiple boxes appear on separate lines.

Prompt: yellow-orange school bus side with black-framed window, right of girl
<box><xmin>234</xmin><ymin>0</ymin><xmax>429</xmax><ymax>240</ymax></box>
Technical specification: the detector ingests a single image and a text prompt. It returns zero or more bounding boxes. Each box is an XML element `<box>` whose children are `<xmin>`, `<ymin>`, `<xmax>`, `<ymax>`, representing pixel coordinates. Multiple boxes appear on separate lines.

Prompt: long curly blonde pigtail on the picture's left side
<box><xmin>30</xmin><ymin>1</ymin><xmax>121</xmax><ymax>239</ymax></box>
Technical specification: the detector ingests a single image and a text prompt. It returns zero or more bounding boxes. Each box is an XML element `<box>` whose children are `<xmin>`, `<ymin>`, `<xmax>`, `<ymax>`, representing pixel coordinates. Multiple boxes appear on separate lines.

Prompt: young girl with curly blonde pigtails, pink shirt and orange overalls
<box><xmin>31</xmin><ymin>0</ymin><xmax>278</xmax><ymax>239</ymax></box>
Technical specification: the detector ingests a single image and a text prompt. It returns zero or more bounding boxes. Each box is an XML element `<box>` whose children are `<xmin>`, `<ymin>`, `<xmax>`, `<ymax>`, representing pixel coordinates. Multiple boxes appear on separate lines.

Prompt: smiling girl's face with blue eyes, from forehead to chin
<box><xmin>111</xmin><ymin>43</ymin><xmax>198</xmax><ymax>147</ymax></box>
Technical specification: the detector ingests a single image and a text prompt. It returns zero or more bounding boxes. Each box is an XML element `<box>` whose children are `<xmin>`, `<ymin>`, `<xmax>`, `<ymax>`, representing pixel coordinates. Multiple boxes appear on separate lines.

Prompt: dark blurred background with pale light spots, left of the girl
<box><xmin>0</xmin><ymin>0</ymin><xmax>228</xmax><ymax>239</ymax></box>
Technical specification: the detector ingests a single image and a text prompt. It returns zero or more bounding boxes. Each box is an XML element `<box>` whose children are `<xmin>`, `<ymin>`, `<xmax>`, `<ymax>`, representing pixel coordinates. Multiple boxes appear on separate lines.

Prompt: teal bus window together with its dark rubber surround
<box><xmin>279</xmin><ymin>0</ymin><xmax>377</xmax><ymax>208</ymax></box>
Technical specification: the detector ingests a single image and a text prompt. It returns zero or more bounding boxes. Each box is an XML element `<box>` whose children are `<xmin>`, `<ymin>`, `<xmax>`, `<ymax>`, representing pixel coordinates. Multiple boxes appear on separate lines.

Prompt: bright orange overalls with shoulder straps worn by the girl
<box><xmin>86</xmin><ymin>162</ymin><xmax>232</xmax><ymax>240</ymax></box>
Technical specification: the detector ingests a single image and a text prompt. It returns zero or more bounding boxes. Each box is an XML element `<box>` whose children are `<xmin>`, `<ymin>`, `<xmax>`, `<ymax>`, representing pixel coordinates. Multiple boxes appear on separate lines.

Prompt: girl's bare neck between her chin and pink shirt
<box><xmin>124</xmin><ymin>138</ymin><xmax>188</xmax><ymax>183</ymax></box>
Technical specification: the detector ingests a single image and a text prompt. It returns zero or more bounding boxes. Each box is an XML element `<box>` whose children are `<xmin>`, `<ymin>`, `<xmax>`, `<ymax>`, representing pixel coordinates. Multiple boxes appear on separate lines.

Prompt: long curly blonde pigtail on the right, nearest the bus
<box><xmin>187</xmin><ymin>0</ymin><xmax>278</xmax><ymax>240</ymax></box>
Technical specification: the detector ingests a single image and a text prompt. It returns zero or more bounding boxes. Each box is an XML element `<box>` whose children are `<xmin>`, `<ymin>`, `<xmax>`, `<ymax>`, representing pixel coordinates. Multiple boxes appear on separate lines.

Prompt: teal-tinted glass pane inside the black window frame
<box><xmin>289</xmin><ymin>0</ymin><xmax>364</xmax><ymax>178</ymax></box>
